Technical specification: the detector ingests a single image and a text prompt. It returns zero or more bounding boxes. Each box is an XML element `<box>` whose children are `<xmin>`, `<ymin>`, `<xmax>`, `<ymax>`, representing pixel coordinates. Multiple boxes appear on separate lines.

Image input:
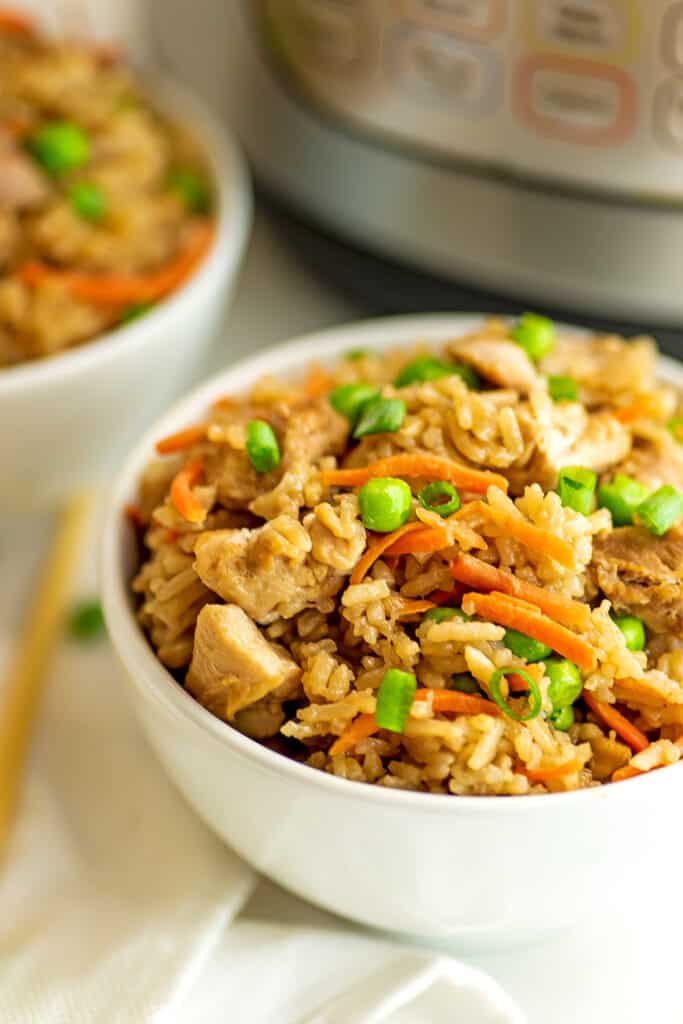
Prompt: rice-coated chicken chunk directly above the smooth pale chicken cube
<box><xmin>195</xmin><ymin>516</ymin><xmax>344</xmax><ymax>624</ymax></box>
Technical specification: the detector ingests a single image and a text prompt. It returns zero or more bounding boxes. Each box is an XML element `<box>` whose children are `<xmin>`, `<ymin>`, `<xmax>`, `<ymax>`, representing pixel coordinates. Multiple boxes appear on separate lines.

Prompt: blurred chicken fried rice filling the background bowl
<box><xmin>0</xmin><ymin>8</ymin><xmax>212</xmax><ymax>369</ymax></box>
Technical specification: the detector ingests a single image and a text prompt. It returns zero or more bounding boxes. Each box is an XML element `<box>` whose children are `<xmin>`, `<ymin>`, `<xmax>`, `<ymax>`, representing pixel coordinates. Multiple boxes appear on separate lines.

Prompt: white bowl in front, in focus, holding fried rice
<box><xmin>101</xmin><ymin>315</ymin><xmax>683</xmax><ymax>946</ymax></box>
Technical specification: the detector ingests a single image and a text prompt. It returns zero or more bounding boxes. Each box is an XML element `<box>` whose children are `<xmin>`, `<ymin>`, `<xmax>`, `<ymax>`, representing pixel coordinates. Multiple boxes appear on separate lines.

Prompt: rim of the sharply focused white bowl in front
<box><xmin>99</xmin><ymin>313</ymin><xmax>683</xmax><ymax>815</ymax></box>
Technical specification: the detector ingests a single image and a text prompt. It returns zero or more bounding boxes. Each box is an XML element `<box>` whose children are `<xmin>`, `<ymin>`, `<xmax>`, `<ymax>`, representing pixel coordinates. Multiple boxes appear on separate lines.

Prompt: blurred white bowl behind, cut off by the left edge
<box><xmin>0</xmin><ymin>78</ymin><xmax>252</xmax><ymax>511</ymax></box>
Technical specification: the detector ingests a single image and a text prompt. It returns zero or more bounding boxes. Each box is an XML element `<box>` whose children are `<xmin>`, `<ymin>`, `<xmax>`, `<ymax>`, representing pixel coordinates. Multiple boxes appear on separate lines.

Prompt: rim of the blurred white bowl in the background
<box><xmin>0</xmin><ymin>75</ymin><xmax>253</xmax><ymax>391</ymax></box>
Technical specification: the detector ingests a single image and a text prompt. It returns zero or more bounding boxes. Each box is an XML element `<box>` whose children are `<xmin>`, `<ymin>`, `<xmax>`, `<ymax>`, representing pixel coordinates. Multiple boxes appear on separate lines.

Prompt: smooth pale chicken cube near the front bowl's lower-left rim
<box><xmin>185</xmin><ymin>604</ymin><xmax>301</xmax><ymax>719</ymax></box>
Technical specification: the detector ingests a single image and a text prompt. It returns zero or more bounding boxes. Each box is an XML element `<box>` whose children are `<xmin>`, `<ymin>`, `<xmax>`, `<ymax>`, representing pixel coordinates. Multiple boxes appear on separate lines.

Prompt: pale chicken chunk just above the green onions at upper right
<box><xmin>507</xmin><ymin>402</ymin><xmax>631</xmax><ymax>494</ymax></box>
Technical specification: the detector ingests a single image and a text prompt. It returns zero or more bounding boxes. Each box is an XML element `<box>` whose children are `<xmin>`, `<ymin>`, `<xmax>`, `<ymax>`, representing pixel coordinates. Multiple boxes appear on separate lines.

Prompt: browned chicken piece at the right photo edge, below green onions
<box><xmin>590</xmin><ymin>526</ymin><xmax>683</xmax><ymax>636</ymax></box>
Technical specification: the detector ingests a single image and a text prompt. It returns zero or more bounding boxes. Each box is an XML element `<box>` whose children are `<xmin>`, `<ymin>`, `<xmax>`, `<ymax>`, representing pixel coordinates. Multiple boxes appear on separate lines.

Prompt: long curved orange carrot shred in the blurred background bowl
<box><xmin>18</xmin><ymin>220</ymin><xmax>214</xmax><ymax>306</ymax></box>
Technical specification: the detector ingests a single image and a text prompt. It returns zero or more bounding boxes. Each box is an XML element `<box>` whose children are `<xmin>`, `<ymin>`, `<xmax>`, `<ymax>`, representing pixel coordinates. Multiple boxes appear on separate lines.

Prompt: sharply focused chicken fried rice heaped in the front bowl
<box><xmin>129</xmin><ymin>314</ymin><xmax>683</xmax><ymax>795</ymax></box>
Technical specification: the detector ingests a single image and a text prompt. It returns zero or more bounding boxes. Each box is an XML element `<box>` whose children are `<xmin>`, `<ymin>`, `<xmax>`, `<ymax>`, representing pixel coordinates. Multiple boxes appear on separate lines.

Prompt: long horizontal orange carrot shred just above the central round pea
<box><xmin>321</xmin><ymin>452</ymin><xmax>508</xmax><ymax>495</ymax></box>
